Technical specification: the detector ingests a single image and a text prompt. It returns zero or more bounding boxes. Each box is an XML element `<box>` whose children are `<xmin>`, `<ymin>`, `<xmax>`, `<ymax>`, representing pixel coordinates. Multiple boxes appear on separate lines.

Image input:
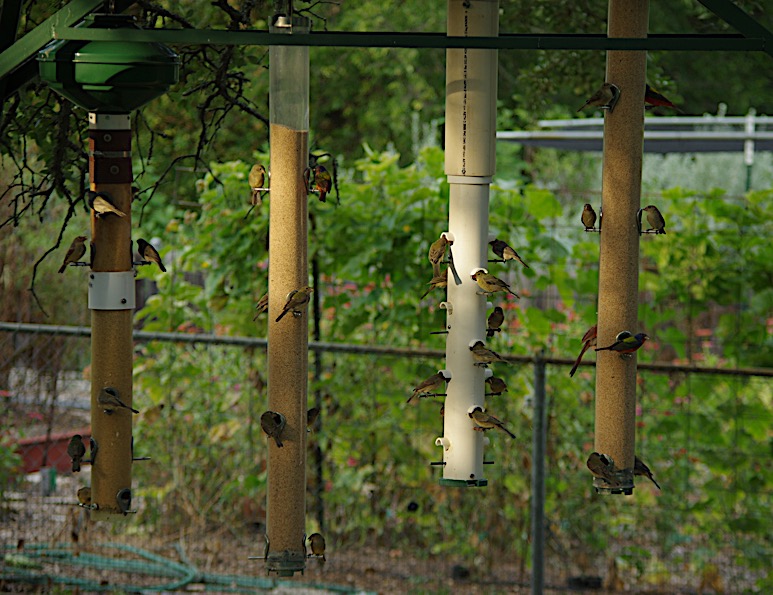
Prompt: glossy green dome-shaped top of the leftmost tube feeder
<box><xmin>38</xmin><ymin>14</ymin><xmax>180</xmax><ymax>114</ymax></box>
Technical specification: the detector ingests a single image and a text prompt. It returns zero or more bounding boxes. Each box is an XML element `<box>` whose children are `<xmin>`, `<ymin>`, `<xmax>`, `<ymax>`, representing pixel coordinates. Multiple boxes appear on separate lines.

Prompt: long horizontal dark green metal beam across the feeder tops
<box><xmin>48</xmin><ymin>26</ymin><xmax>765</xmax><ymax>51</ymax></box>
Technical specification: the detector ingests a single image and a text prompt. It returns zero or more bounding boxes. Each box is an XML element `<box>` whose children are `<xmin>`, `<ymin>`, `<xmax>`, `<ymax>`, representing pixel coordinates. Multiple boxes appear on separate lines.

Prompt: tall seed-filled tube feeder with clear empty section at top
<box><xmin>266</xmin><ymin>10</ymin><xmax>309</xmax><ymax>576</ymax></box>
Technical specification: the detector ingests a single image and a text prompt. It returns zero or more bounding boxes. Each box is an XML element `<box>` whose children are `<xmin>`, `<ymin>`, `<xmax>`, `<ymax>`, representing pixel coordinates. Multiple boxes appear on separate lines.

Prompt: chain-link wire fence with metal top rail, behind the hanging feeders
<box><xmin>0</xmin><ymin>323</ymin><xmax>773</xmax><ymax>593</ymax></box>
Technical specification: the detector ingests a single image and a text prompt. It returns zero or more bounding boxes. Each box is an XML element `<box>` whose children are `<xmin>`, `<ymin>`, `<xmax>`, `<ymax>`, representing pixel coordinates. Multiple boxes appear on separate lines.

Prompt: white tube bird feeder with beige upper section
<box><xmin>435</xmin><ymin>0</ymin><xmax>499</xmax><ymax>487</ymax></box>
